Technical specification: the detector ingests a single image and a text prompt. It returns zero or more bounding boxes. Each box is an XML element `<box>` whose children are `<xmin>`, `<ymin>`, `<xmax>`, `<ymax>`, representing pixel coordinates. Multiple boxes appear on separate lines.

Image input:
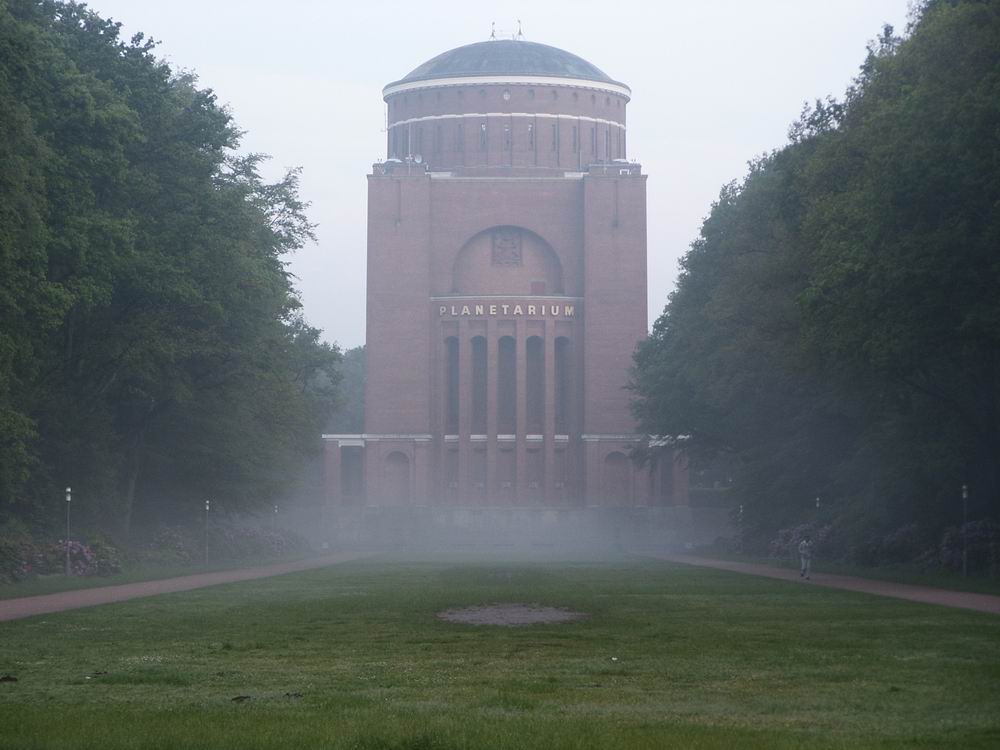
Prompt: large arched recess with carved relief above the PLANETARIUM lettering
<box><xmin>451</xmin><ymin>226</ymin><xmax>565</xmax><ymax>296</ymax></box>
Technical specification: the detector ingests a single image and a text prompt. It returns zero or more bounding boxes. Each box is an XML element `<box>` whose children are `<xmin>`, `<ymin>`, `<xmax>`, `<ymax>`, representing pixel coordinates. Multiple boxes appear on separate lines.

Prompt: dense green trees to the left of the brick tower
<box><xmin>0</xmin><ymin>0</ymin><xmax>339</xmax><ymax>540</ymax></box>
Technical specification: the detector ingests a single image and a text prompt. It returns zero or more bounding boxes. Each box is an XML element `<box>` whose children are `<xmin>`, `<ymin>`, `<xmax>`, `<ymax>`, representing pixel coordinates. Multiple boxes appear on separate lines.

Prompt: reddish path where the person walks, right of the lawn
<box><xmin>649</xmin><ymin>553</ymin><xmax>1000</xmax><ymax>615</ymax></box>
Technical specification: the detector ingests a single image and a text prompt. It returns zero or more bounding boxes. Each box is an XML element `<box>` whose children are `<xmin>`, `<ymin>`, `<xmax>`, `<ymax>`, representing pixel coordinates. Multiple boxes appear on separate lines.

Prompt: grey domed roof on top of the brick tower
<box><xmin>386</xmin><ymin>39</ymin><xmax>627</xmax><ymax>89</ymax></box>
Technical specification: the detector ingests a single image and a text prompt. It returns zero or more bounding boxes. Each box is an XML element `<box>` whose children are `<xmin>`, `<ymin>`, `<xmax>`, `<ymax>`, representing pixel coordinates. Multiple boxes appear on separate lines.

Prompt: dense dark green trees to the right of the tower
<box><xmin>633</xmin><ymin>0</ymin><xmax>1000</xmax><ymax>560</ymax></box>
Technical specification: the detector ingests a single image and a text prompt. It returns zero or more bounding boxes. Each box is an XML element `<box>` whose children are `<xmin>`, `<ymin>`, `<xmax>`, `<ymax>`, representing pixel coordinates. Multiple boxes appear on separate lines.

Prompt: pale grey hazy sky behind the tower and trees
<box><xmin>90</xmin><ymin>0</ymin><xmax>909</xmax><ymax>348</ymax></box>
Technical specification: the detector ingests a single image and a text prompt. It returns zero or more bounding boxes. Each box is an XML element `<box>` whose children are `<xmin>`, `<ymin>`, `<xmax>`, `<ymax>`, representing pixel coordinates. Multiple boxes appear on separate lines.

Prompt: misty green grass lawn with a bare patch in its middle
<box><xmin>0</xmin><ymin>558</ymin><xmax>1000</xmax><ymax>750</ymax></box>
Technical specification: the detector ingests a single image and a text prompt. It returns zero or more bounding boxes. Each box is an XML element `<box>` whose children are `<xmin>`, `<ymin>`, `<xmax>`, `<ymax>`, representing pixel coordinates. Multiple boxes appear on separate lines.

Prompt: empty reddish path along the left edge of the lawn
<box><xmin>0</xmin><ymin>552</ymin><xmax>367</xmax><ymax>621</ymax></box>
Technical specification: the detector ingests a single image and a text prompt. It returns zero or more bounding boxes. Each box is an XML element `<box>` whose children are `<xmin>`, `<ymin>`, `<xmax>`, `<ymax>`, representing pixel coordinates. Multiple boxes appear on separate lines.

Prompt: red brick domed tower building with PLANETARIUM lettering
<box><xmin>324</xmin><ymin>40</ymin><xmax>687</xmax><ymax>548</ymax></box>
